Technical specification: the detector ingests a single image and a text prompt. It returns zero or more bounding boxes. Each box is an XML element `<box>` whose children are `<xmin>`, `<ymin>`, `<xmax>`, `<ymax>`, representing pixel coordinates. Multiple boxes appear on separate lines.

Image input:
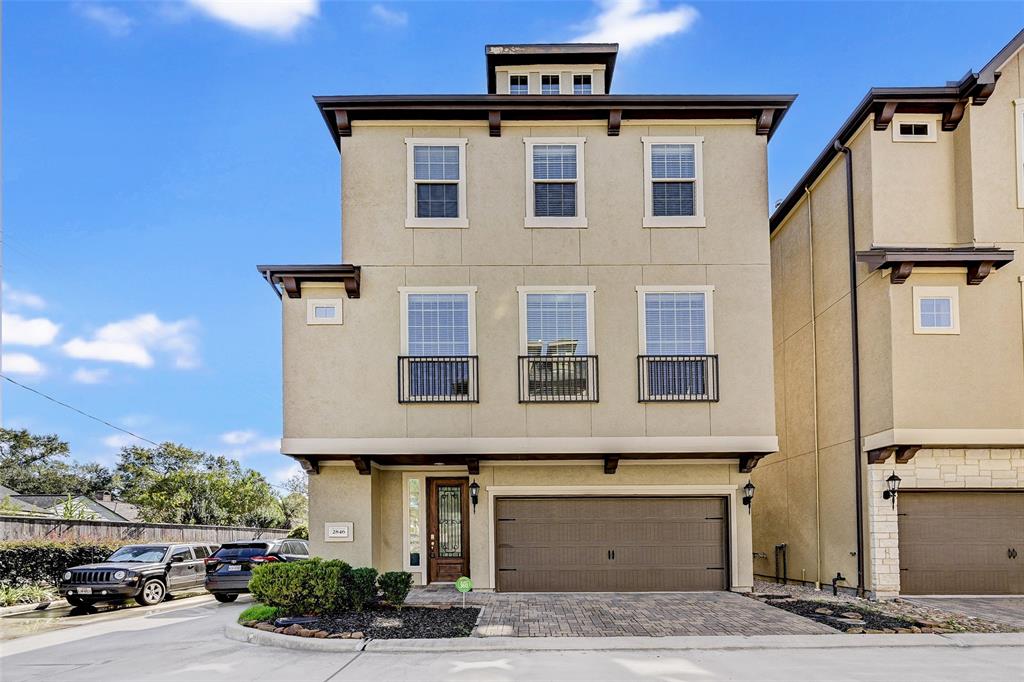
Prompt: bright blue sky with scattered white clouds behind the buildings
<box><xmin>2</xmin><ymin>0</ymin><xmax>1024</xmax><ymax>479</ymax></box>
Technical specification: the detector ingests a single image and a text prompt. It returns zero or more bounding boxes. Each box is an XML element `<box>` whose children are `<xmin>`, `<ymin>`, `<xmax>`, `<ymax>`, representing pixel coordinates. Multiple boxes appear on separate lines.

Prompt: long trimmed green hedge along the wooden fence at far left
<box><xmin>0</xmin><ymin>540</ymin><xmax>125</xmax><ymax>585</ymax></box>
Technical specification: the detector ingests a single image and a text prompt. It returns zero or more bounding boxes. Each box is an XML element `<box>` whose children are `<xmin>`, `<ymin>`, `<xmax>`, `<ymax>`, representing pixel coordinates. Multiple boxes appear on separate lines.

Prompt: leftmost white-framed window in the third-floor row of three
<box><xmin>406</xmin><ymin>137</ymin><xmax>469</xmax><ymax>227</ymax></box>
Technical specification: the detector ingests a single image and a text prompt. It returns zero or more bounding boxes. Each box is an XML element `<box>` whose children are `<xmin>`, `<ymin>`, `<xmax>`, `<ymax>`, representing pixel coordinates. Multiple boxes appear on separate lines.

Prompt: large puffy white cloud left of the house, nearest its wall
<box><xmin>61</xmin><ymin>312</ymin><xmax>199</xmax><ymax>370</ymax></box>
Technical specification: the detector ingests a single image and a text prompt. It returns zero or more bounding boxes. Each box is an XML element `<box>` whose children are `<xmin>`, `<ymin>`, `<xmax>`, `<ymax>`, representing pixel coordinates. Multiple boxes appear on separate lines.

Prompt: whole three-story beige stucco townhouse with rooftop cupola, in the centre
<box><xmin>260</xmin><ymin>44</ymin><xmax>794</xmax><ymax>591</ymax></box>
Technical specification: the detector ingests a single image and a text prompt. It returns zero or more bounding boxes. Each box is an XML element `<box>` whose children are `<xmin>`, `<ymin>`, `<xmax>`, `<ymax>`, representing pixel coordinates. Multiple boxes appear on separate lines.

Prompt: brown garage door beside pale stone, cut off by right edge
<box><xmin>899</xmin><ymin>491</ymin><xmax>1024</xmax><ymax>594</ymax></box>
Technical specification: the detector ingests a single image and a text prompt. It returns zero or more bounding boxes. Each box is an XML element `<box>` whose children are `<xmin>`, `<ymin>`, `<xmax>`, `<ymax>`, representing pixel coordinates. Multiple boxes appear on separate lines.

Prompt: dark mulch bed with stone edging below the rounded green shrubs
<box><xmin>243</xmin><ymin>606</ymin><xmax>480</xmax><ymax>639</ymax></box>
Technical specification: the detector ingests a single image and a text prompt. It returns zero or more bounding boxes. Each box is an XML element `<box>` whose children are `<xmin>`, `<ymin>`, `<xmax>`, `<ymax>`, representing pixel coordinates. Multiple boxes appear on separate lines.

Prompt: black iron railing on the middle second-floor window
<box><xmin>519</xmin><ymin>355</ymin><xmax>598</xmax><ymax>402</ymax></box>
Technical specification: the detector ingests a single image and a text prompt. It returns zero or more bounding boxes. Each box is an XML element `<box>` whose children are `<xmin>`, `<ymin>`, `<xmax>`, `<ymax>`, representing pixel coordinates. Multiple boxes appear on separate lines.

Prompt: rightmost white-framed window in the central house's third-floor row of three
<box><xmin>642</xmin><ymin>136</ymin><xmax>705</xmax><ymax>227</ymax></box>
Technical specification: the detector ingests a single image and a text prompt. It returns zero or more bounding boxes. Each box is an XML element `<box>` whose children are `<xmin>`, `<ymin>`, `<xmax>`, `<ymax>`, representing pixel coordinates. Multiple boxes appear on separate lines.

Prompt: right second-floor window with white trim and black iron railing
<box><xmin>637</xmin><ymin>286</ymin><xmax>718</xmax><ymax>401</ymax></box>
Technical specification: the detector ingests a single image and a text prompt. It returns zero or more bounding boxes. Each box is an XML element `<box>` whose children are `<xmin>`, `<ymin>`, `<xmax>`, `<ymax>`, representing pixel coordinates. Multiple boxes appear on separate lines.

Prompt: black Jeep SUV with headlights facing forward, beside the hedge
<box><xmin>60</xmin><ymin>543</ymin><xmax>217</xmax><ymax>606</ymax></box>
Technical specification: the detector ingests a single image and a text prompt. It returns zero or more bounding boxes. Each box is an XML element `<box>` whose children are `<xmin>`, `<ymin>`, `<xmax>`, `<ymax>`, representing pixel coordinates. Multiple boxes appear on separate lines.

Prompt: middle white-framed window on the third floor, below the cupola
<box><xmin>523</xmin><ymin>137</ymin><xmax>587</xmax><ymax>227</ymax></box>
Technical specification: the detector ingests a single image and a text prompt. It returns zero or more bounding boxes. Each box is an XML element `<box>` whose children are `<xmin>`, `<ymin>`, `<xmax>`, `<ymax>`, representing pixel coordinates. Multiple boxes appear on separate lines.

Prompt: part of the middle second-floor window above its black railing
<box><xmin>526</xmin><ymin>293</ymin><xmax>590</xmax><ymax>355</ymax></box>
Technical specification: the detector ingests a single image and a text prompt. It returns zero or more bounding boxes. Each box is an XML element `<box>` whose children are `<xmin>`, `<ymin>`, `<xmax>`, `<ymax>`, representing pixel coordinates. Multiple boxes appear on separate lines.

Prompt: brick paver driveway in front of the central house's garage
<box><xmin>406</xmin><ymin>586</ymin><xmax>836</xmax><ymax>637</ymax></box>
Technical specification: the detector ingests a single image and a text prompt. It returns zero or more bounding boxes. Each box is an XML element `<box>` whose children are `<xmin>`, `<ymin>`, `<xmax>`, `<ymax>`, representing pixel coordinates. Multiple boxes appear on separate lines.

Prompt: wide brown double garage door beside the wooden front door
<box><xmin>495</xmin><ymin>498</ymin><xmax>728</xmax><ymax>592</ymax></box>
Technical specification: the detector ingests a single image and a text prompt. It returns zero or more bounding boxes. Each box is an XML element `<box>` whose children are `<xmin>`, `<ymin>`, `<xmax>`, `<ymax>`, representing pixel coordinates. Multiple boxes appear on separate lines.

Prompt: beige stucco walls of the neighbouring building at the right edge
<box><xmin>754</xmin><ymin>38</ymin><xmax>1024</xmax><ymax>597</ymax></box>
